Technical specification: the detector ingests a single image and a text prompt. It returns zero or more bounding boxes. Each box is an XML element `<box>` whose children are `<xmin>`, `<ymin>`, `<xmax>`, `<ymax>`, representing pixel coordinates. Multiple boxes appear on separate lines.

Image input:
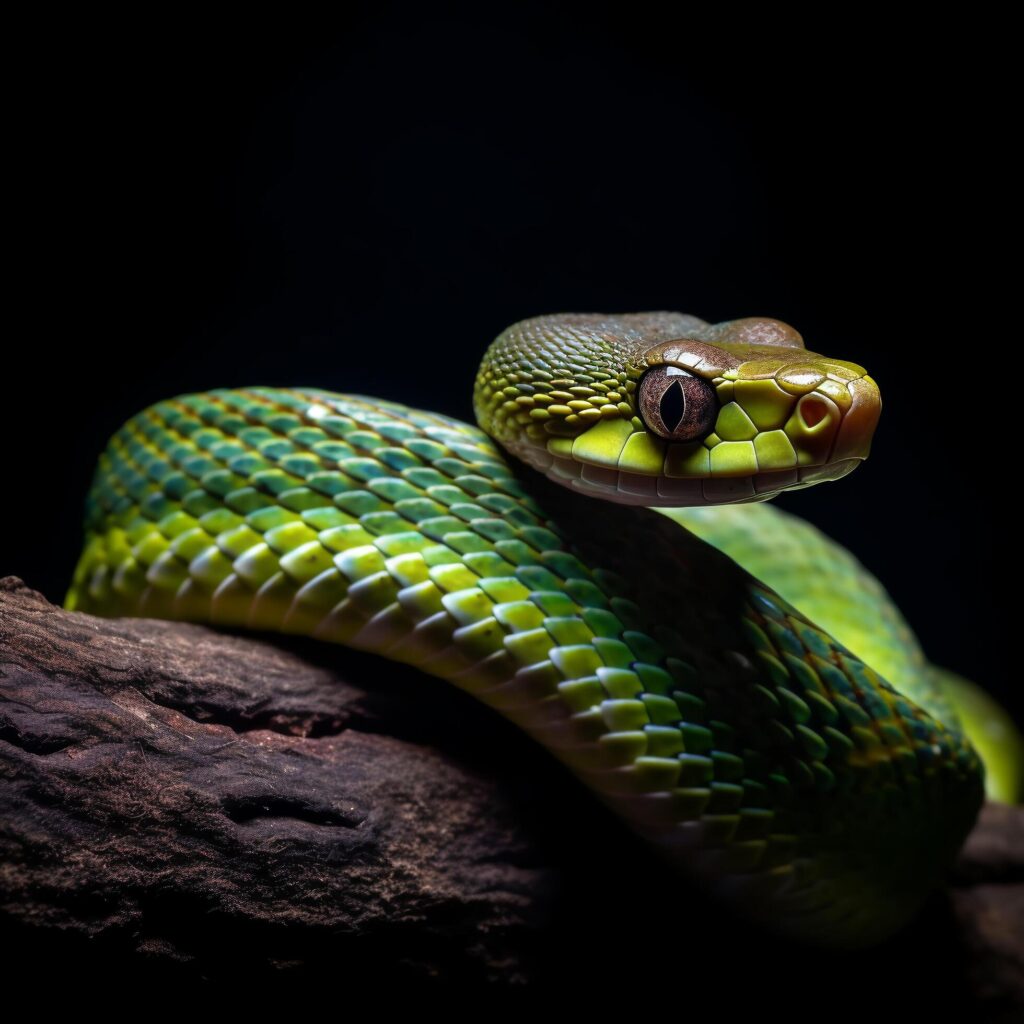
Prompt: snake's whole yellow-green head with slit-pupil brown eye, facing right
<box><xmin>474</xmin><ymin>312</ymin><xmax>882</xmax><ymax>506</ymax></box>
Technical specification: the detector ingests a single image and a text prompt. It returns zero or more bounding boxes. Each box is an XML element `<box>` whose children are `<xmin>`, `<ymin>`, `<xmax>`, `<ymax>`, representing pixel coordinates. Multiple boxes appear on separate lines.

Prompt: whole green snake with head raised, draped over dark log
<box><xmin>67</xmin><ymin>312</ymin><xmax>1011</xmax><ymax>946</ymax></box>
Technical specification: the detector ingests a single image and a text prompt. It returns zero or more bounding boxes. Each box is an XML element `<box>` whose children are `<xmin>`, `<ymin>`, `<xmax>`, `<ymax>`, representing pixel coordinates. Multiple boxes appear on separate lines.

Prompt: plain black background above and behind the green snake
<box><xmin>6</xmin><ymin>12</ymin><xmax>1019</xmax><ymax>724</ymax></box>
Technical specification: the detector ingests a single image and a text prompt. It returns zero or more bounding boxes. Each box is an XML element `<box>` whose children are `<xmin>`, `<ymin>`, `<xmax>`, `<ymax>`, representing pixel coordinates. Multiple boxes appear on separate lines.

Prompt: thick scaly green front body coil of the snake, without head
<box><xmin>68</xmin><ymin>388</ymin><xmax>980</xmax><ymax>944</ymax></box>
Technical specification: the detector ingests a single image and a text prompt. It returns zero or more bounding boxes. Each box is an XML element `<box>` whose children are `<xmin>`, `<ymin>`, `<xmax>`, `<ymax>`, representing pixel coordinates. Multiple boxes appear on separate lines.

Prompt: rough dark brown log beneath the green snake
<box><xmin>0</xmin><ymin>578</ymin><xmax>1024</xmax><ymax>1020</ymax></box>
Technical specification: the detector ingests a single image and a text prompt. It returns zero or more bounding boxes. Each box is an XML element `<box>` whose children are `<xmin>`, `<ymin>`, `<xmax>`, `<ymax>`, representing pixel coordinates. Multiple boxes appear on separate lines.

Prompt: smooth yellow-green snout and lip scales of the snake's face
<box><xmin>516</xmin><ymin>373</ymin><xmax>882</xmax><ymax>507</ymax></box>
